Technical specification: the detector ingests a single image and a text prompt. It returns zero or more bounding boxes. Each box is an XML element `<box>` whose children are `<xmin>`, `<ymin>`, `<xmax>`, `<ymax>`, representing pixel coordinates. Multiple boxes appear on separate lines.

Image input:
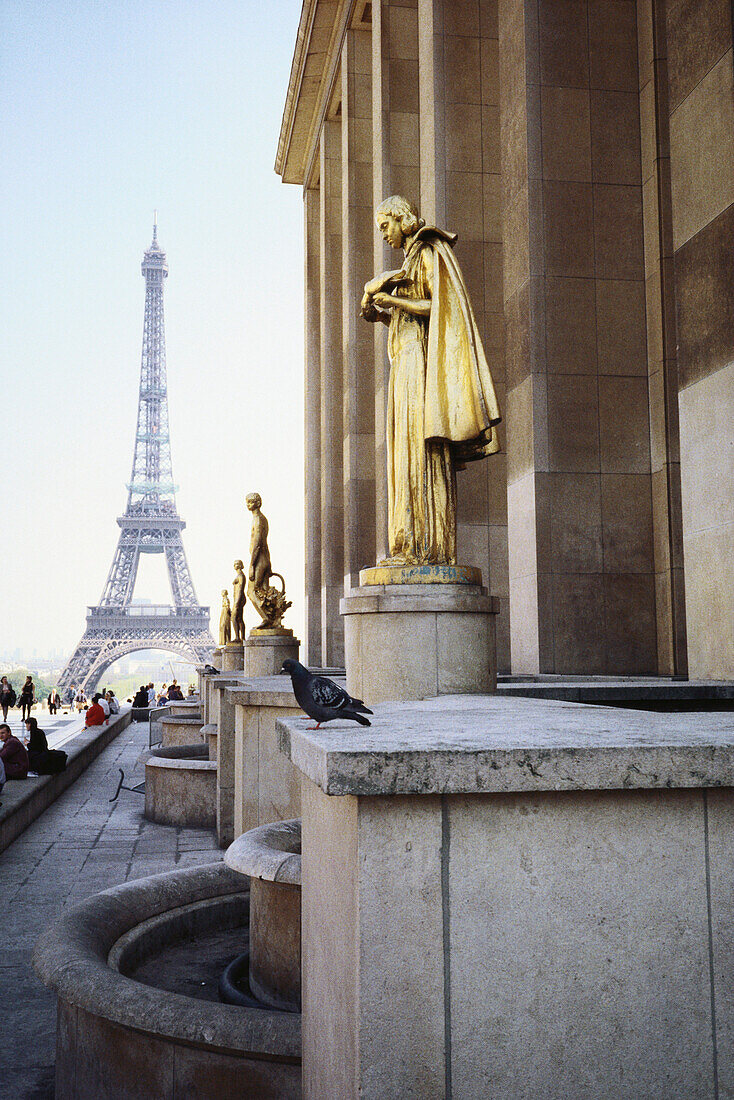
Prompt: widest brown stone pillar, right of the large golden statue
<box><xmin>500</xmin><ymin>0</ymin><xmax>658</xmax><ymax>674</ymax></box>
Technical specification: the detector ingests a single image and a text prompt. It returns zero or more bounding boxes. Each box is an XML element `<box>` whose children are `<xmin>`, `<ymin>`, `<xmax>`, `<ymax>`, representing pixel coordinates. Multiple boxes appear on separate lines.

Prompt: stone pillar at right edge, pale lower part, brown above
<box><xmin>661</xmin><ymin>0</ymin><xmax>734</xmax><ymax>679</ymax></box>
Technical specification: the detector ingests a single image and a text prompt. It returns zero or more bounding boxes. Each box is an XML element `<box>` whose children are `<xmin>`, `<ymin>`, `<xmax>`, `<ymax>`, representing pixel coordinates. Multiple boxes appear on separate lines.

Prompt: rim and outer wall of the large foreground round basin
<box><xmin>34</xmin><ymin>862</ymin><xmax>300</xmax><ymax>1100</ymax></box>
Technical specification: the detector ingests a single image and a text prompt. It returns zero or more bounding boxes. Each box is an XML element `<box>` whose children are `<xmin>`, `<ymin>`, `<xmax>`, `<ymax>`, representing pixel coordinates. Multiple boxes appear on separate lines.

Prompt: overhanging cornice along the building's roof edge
<box><xmin>275</xmin><ymin>0</ymin><xmax>355</xmax><ymax>185</ymax></box>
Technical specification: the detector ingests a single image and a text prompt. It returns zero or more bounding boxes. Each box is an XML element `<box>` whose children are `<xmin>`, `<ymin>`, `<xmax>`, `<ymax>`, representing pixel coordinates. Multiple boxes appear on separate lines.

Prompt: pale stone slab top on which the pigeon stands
<box><xmin>276</xmin><ymin>695</ymin><xmax>734</xmax><ymax>795</ymax></box>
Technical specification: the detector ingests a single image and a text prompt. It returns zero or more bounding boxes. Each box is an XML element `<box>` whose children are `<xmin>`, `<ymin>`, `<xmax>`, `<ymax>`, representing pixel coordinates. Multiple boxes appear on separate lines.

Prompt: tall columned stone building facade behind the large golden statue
<box><xmin>276</xmin><ymin>0</ymin><xmax>734</xmax><ymax>678</ymax></box>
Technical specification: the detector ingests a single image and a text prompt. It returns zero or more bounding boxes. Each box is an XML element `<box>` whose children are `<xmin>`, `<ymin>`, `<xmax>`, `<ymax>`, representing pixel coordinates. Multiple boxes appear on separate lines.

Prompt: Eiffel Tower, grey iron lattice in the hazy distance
<box><xmin>58</xmin><ymin>220</ymin><xmax>215</xmax><ymax>691</ymax></box>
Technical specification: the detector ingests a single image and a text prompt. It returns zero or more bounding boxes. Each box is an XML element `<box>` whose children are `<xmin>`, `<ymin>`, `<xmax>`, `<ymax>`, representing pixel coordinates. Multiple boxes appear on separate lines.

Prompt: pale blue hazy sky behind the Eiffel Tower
<box><xmin>0</xmin><ymin>0</ymin><xmax>303</xmax><ymax>653</ymax></box>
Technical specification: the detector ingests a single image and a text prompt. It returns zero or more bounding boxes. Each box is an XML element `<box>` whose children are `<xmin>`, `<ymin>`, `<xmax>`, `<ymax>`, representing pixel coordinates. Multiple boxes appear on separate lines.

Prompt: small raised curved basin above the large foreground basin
<box><xmin>224</xmin><ymin>818</ymin><xmax>300</xmax><ymax>1012</ymax></box>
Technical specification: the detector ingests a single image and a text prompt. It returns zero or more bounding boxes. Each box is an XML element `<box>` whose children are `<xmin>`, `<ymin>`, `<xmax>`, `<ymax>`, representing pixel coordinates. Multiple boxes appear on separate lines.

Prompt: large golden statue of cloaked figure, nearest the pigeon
<box><xmin>361</xmin><ymin>195</ymin><xmax>501</xmax><ymax>565</ymax></box>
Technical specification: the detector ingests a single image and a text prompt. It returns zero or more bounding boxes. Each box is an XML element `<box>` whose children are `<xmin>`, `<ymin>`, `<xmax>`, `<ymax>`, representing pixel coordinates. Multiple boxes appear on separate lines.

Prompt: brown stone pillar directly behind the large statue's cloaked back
<box><xmin>418</xmin><ymin>0</ymin><xmax>510</xmax><ymax>672</ymax></box>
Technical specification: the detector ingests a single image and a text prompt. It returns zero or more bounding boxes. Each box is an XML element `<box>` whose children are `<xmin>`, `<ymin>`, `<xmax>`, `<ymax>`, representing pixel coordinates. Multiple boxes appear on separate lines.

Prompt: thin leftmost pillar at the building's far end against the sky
<box><xmin>304</xmin><ymin>187</ymin><xmax>321</xmax><ymax>666</ymax></box>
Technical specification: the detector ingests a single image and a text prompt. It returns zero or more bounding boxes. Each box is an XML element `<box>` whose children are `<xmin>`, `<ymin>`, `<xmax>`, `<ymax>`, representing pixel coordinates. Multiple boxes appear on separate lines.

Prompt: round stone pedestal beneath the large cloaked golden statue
<box><xmin>341</xmin><ymin>565</ymin><xmax>499</xmax><ymax>704</ymax></box>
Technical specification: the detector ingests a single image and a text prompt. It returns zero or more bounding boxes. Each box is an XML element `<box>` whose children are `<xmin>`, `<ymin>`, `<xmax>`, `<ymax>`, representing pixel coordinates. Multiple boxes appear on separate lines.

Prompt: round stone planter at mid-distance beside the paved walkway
<box><xmin>144</xmin><ymin>744</ymin><xmax>217</xmax><ymax>828</ymax></box>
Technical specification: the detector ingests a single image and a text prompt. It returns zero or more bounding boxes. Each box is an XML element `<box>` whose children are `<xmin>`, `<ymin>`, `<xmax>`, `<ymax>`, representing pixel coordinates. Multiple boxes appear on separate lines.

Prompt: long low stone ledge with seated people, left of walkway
<box><xmin>0</xmin><ymin>710</ymin><xmax>132</xmax><ymax>851</ymax></box>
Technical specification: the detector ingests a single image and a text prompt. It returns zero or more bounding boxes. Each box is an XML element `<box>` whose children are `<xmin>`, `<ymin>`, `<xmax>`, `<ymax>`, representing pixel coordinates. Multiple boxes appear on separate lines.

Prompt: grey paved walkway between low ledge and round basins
<box><xmin>0</xmin><ymin>723</ymin><xmax>221</xmax><ymax>1100</ymax></box>
